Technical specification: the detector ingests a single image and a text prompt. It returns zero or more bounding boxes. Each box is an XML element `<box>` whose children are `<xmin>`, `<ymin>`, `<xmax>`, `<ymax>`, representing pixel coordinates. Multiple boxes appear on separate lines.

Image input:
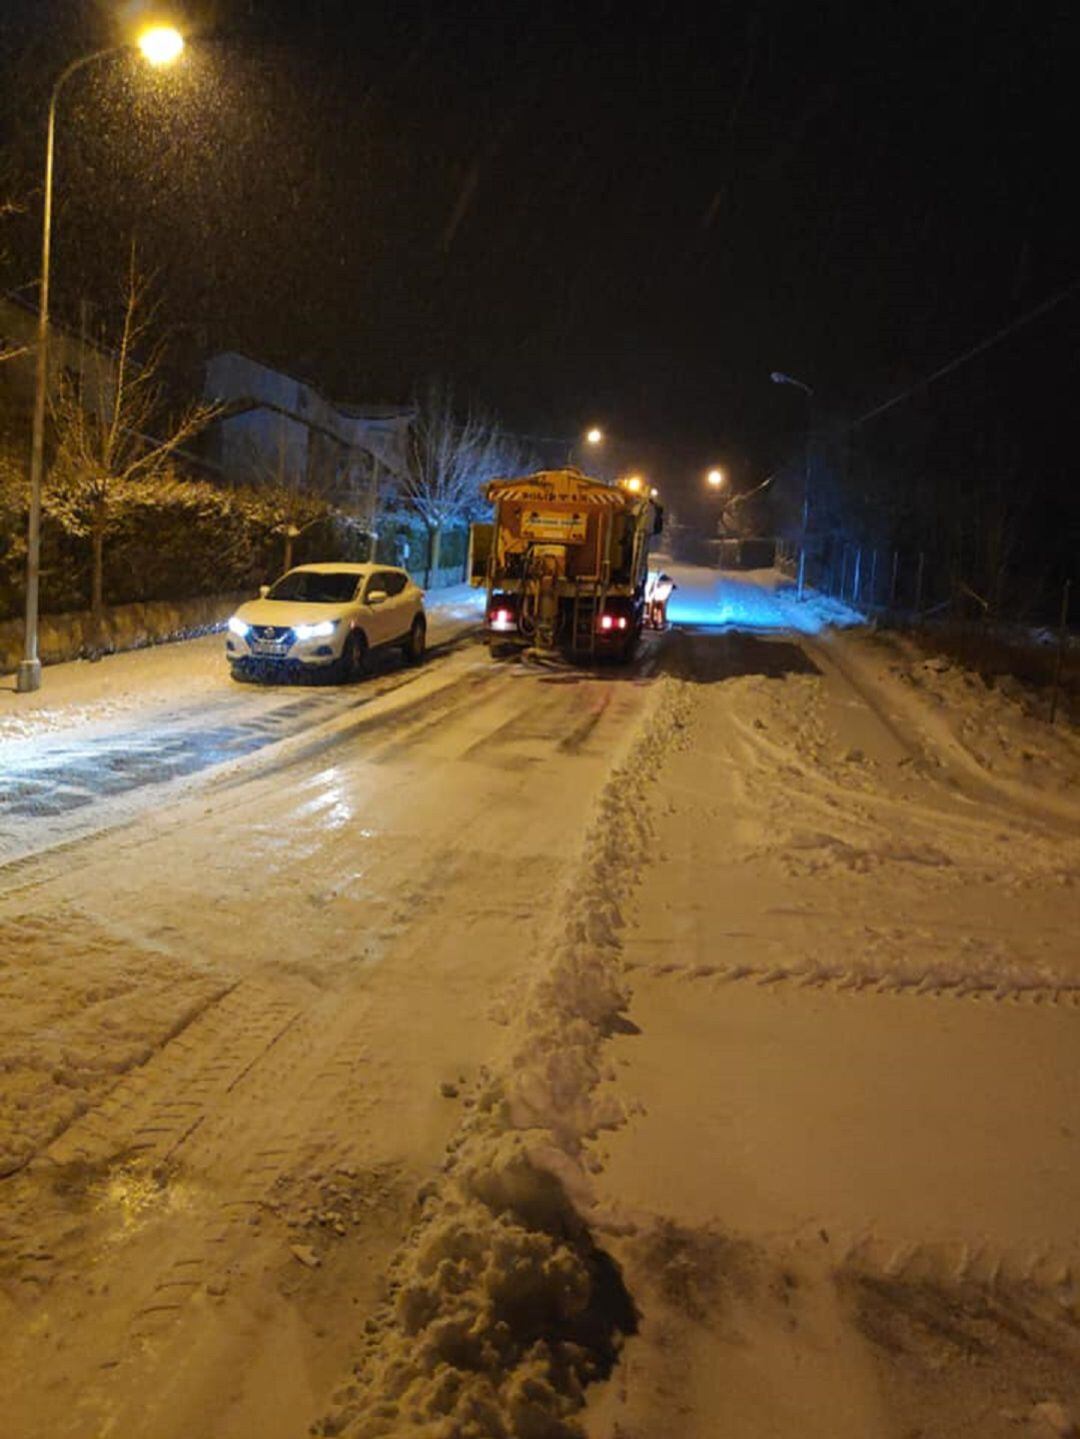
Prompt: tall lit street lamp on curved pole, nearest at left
<box><xmin>16</xmin><ymin>24</ymin><xmax>184</xmax><ymax>692</ymax></box>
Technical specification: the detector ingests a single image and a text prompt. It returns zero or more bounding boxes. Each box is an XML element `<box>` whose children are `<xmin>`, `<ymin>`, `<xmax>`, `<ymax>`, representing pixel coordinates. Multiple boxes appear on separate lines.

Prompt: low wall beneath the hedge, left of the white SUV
<box><xmin>0</xmin><ymin>590</ymin><xmax>252</xmax><ymax>673</ymax></box>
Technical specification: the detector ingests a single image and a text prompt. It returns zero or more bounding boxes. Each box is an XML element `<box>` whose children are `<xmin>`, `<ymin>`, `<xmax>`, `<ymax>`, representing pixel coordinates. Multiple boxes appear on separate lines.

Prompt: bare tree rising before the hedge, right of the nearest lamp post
<box><xmin>46</xmin><ymin>249</ymin><xmax>221</xmax><ymax>625</ymax></box>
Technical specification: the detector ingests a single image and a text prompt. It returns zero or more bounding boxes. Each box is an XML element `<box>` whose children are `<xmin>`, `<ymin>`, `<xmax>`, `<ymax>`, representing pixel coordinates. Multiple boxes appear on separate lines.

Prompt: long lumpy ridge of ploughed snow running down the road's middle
<box><xmin>315</xmin><ymin>681</ymin><xmax>689</xmax><ymax>1439</ymax></box>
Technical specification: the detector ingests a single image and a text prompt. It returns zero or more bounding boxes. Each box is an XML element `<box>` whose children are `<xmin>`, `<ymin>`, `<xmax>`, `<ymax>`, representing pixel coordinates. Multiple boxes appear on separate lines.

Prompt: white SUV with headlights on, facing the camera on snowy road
<box><xmin>224</xmin><ymin>564</ymin><xmax>427</xmax><ymax>679</ymax></box>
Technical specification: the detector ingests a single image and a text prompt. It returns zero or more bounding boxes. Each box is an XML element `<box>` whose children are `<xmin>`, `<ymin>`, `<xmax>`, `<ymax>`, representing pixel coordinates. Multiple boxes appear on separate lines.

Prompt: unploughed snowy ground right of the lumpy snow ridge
<box><xmin>588</xmin><ymin>566</ymin><xmax>1080</xmax><ymax>1439</ymax></box>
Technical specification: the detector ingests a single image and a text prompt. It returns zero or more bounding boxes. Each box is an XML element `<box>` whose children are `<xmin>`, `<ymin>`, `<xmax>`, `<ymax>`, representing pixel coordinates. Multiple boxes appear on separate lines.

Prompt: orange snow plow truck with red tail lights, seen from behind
<box><xmin>469</xmin><ymin>468</ymin><xmax>663</xmax><ymax>661</ymax></box>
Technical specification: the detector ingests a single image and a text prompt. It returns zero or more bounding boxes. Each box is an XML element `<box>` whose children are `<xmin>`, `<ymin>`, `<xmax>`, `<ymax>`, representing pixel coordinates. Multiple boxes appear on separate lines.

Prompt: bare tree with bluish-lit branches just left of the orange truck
<box><xmin>400</xmin><ymin>381</ymin><xmax>528</xmax><ymax>583</ymax></box>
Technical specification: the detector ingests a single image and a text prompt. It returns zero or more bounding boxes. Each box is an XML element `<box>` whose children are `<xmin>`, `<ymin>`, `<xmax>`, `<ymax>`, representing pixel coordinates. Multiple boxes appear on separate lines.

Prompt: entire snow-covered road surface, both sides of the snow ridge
<box><xmin>0</xmin><ymin>568</ymin><xmax>1080</xmax><ymax>1439</ymax></box>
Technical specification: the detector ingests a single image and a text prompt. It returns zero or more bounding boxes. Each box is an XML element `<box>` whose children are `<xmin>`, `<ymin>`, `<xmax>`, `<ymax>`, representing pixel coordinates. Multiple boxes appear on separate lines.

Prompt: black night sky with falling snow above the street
<box><xmin>0</xmin><ymin>0</ymin><xmax>1080</xmax><ymax>506</ymax></box>
